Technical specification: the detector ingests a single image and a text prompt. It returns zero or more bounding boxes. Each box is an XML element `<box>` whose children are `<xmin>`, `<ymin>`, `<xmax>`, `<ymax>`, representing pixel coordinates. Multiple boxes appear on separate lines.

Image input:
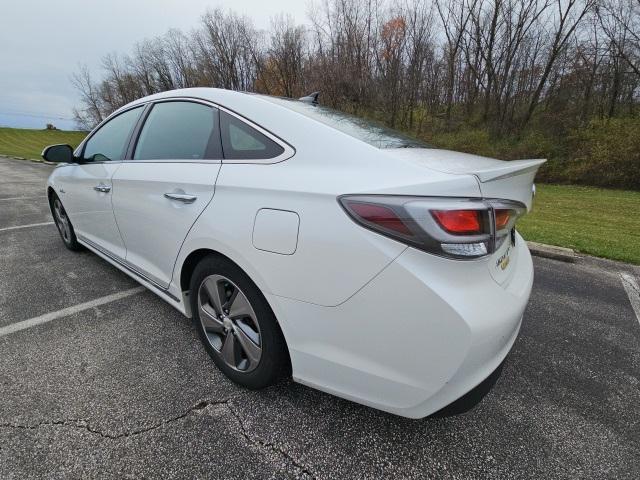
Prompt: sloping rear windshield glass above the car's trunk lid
<box><xmin>255</xmin><ymin>95</ymin><xmax>432</xmax><ymax>148</ymax></box>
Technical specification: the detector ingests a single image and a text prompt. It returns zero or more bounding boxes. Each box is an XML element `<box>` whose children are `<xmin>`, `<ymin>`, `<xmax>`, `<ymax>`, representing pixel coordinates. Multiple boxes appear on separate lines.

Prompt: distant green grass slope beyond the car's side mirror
<box><xmin>0</xmin><ymin>128</ymin><xmax>86</xmax><ymax>159</ymax></box>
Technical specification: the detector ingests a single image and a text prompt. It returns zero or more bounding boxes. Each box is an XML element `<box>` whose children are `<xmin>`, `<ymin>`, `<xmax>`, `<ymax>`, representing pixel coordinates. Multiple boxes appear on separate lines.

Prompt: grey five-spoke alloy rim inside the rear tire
<box><xmin>198</xmin><ymin>275</ymin><xmax>262</xmax><ymax>373</ymax></box>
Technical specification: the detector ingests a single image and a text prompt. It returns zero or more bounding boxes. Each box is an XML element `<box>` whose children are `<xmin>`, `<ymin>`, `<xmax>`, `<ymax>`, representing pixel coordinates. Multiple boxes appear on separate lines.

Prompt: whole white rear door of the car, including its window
<box><xmin>113</xmin><ymin>100</ymin><xmax>222</xmax><ymax>288</ymax></box>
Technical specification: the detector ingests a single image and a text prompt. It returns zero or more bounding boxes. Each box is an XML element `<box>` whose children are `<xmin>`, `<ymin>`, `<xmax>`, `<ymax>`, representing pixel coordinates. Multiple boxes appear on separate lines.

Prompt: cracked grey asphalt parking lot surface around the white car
<box><xmin>0</xmin><ymin>158</ymin><xmax>640</xmax><ymax>479</ymax></box>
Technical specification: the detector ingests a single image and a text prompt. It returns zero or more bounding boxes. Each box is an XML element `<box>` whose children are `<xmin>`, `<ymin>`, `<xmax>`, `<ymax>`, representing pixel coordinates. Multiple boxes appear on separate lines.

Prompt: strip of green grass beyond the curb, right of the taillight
<box><xmin>517</xmin><ymin>185</ymin><xmax>640</xmax><ymax>265</ymax></box>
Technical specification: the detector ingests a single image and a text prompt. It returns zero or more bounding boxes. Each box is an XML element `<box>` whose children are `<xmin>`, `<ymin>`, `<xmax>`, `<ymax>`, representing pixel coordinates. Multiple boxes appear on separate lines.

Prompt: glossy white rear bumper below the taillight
<box><xmin>269</xmin><ymin>232</ymin><xmax>533</xmax><ymax>418</ymax></box>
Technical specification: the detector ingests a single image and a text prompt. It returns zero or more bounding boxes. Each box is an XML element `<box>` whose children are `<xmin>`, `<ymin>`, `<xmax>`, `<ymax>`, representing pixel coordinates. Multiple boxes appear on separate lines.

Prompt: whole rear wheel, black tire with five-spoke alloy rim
<box><xmin>190</xmin><ymin>255</ymin><xmax>290</xmax><ymax>389</ymax></box>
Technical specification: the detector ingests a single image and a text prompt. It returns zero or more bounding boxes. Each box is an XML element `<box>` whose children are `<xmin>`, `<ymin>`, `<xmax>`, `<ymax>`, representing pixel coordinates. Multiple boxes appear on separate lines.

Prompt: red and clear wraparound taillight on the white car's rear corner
<box><xmin>338</xmin><ymin>195</ymin><xmax>526</xmax><ymax>259</ymax></box>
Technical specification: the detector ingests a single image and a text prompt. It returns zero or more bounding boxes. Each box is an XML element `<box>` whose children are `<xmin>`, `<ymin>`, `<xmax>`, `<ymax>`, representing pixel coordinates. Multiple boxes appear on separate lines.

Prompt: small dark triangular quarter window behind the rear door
<box><xmin>220</xmin><ymin>111</ymin><xmax>284</xmax><ymax>160</ymax></box>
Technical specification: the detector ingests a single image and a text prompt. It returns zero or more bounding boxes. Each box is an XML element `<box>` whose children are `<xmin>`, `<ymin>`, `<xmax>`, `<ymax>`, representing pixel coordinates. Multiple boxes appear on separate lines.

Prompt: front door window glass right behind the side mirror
<box><xmin>82</xmin><ymin>106</ymin><xmax>143</xmax><ymax>162</ymax></box>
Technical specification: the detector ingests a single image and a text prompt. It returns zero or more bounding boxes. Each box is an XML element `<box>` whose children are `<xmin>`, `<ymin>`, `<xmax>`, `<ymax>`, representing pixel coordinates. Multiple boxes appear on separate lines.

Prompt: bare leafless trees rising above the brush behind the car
<box><xmin>72</xmin><ymin>0</ymin><xmax>640</xmax><ymax>187</ymax></box>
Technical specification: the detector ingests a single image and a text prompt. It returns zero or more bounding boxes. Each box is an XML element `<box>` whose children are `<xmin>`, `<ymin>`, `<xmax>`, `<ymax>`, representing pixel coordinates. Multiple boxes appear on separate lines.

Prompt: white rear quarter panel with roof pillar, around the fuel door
<box><xmin>173</xmin><ymin>114</ymin><xmax>480</xmax><ymax>306</ymax></box>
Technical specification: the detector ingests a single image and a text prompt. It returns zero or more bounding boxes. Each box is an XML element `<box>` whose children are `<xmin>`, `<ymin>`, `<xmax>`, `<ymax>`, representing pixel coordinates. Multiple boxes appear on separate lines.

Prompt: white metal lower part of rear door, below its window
<box><xmin>113</xmin><ymin>161</ymin><xmax>221</xmax><ymax>288</ymax></box>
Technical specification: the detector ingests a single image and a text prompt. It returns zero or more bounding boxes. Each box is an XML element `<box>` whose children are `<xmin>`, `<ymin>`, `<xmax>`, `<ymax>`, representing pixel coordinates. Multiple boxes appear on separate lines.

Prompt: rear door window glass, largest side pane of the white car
<box><xmin>133</xmin><ymin>101</ymin><xmax>222</xmax><ymax>160</ymax></box>
